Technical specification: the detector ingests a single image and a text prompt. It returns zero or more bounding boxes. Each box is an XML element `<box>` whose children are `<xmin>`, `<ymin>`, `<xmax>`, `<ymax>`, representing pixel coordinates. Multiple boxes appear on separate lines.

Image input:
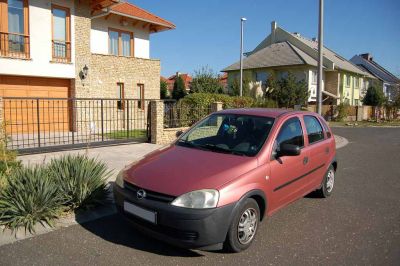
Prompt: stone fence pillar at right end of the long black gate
<box><xmin>150</xmin><ymin>100</ymin><xmax>164</xmax><ymax>144</ymax></box>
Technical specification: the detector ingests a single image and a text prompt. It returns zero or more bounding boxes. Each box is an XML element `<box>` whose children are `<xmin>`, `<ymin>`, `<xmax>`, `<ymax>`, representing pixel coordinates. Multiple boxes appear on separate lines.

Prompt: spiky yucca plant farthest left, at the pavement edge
<box><xmin>0</xmin><ymin>166</ymin><xmax>63</xmax><ymax>233</ymax></box>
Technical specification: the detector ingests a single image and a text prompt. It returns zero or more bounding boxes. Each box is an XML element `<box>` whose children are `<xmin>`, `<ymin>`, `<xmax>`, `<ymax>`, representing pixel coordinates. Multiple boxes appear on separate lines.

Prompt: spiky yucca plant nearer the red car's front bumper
<box><xmin>48</xmin><ymin>155</ymin><xmax>111</xmax><ymax>210</ymax></box>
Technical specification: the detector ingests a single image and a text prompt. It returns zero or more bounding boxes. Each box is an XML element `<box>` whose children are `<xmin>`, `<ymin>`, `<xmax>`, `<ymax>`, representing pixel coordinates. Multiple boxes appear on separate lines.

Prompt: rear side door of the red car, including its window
<box><xmin>303</xmin><ymin>115</ymin><xmax>330</xmax><ymax>190</ymax></box>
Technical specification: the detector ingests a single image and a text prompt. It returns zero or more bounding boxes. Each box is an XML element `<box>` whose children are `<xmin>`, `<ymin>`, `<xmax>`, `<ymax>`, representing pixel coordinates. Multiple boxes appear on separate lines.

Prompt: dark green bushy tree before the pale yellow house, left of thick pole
<box><xmin>266</xmin><ymin>72</ymin><xmax>308</xmax><ymax>108</ymax></box>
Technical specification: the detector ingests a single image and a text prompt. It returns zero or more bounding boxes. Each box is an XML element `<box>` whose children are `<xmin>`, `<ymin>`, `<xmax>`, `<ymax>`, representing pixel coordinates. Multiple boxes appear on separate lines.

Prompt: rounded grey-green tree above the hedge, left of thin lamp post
<box><xmin>190</xmin><ymin>66</ymin><xmax>223</xmax><ymax>93</ymax></box>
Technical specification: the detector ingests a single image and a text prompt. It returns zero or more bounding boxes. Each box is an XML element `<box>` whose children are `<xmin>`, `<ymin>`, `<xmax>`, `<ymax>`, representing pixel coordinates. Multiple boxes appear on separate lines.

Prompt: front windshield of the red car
<box><xmin>176</xmin><ymin>114</ymin><xmax>274</xmax><ymax>156</ymax></box>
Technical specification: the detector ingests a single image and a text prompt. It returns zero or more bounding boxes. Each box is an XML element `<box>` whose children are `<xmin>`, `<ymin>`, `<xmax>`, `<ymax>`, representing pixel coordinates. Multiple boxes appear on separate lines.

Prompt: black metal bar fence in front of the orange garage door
<box><xmin>3</xmin><ymin>97</ymin><xmax>150</xmax><ymax>153</ymax></box>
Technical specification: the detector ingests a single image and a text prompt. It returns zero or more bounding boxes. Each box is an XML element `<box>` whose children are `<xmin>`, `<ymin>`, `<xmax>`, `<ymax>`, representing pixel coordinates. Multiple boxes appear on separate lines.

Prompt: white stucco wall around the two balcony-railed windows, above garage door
<box><xmin>0</xmin><ymin>0</ymin><xmax>75</xmax><ymax>78</ymax></box>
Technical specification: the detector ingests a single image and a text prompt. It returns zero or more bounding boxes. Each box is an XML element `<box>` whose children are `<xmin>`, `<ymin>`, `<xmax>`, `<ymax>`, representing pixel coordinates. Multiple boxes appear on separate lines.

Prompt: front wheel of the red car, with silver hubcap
<box><xmin>224</xmin><ymin>198</ymin><xmax>260</xmax><ymax>253</ymax></box>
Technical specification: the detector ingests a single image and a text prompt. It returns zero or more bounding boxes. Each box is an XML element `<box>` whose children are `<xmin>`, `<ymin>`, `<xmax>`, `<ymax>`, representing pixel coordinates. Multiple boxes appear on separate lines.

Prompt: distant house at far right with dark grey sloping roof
<box><xmin>350</xmin><ymin>53</ymin><xmax>400</xmax><ymax>101</ymax></box>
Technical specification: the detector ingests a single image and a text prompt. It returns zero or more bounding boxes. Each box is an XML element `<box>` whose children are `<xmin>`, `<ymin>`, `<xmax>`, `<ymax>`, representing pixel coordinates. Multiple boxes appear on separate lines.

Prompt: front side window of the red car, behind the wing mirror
<box><xmin>275</xmin><ymin>117</ymin><xmax>304</xmax><ymax>151</ymax></box>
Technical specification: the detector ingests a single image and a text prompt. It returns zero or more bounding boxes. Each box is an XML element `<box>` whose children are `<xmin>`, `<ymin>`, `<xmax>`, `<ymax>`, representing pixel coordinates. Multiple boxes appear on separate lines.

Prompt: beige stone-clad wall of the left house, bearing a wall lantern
<box><xmin>71</xmin><ymin>0</ymin><xmax>160</xmax><ymax>99</ymax></box>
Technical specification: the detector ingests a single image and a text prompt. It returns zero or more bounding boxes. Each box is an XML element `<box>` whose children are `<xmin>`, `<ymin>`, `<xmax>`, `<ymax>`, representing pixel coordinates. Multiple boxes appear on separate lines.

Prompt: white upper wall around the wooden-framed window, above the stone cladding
<box><xmin>90</xmin><ymin>16</ymin><xmax>150</xmax><ymax>59</ymax></box>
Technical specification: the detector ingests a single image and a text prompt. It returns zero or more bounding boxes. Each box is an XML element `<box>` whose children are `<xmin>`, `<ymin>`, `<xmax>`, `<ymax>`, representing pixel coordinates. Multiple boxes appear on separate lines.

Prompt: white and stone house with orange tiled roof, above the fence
<box><xmin>0</xmin><ymin>0</ymin><xmax>175</xmax><ymax>133</ymax></box>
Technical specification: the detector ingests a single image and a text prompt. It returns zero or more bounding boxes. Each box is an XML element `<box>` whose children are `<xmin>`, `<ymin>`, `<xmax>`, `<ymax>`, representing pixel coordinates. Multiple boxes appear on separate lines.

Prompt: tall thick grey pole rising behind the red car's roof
<box><xmin>317</xmin><ymin>0</ymin><xmax>324</xmax><ymax>114</ymax></box>
